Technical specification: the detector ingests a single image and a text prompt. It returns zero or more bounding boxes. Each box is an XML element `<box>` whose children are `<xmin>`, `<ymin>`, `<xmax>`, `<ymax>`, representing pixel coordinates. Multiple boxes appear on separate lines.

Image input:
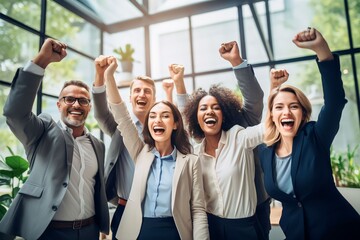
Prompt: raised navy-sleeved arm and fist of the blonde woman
<box><xmin>293</xmin><ymin>28</ymin><xmax>347</xmax><ymax>148</ymax></box>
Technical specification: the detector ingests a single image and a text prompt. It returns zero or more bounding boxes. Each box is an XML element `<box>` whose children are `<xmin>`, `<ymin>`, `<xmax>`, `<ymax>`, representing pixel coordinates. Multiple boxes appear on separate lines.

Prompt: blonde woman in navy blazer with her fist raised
<box><xmin>261</xmin><ymin>28</ymin><xmax>360</xmax><ymax>240</ymax></box>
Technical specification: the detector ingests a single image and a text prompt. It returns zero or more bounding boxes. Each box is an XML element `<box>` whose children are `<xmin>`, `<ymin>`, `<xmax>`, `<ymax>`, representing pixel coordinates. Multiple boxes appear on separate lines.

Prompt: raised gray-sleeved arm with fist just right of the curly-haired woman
<box><xmin>219</xmin><ymin>41</ymin><xmax>264</xmax><ymax>127</ymax></box>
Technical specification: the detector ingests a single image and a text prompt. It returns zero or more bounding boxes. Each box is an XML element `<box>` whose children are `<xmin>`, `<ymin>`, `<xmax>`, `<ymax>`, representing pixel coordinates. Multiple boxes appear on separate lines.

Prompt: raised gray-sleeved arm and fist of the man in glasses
<box><xmin>3</xmin><ymin>38</ymin><xmax>67</xmax><ymax>147</ymax></box>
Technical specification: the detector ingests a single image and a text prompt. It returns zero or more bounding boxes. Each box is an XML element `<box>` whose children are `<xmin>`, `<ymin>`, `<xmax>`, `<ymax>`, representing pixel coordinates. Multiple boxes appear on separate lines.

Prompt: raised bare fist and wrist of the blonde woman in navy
<box><xmin>292</xmin><ymin>27</ymin><xmax>333</xmax><ymax>62</ymax></box>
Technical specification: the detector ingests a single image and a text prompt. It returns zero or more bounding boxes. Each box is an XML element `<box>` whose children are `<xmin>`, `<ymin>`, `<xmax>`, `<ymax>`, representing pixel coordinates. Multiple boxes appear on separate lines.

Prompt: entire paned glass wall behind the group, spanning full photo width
<box><xmin>0</xmin><ymin>0</ymin><xmax>360</xmax><ymax>163</ymax></box>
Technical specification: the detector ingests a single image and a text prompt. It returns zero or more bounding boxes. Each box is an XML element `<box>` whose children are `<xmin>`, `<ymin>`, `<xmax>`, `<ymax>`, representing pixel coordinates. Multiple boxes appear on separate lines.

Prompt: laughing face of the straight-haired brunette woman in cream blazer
<box><xmin>148</xmin><ymin>103</ymin><xmax>177</xmax><ymax>144</ymax></box>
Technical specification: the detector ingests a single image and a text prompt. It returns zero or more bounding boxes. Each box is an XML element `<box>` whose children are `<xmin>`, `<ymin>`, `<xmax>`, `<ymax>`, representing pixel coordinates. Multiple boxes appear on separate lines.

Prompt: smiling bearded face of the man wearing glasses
<box><xmin>56</xmin><ymin>85</ymin><xmax>91</xmax><ymax>129</ymax></box>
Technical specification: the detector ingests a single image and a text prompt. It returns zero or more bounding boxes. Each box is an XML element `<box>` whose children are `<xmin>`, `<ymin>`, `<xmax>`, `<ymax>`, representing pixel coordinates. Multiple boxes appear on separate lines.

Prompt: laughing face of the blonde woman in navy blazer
<box><xmin>271</xmin><ymin>92</ymin><xmax>304</xmax><ymax>141</ymax></box>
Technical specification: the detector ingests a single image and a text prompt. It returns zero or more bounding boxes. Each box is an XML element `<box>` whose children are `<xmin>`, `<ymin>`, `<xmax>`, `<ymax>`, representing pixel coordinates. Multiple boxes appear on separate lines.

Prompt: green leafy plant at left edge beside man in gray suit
<box><xmin>0</xmin><ymin>147</ymin><xmax>29</xmax><ymax>220</ymax></box>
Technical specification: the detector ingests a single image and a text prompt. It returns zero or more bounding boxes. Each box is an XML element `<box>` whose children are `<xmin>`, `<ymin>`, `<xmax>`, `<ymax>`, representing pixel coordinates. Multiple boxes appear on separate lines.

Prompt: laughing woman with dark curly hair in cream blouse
<box><xmin>184</xmin><ymin>85</ymin><xmax>264</xmax><ymax>239</ymax></box>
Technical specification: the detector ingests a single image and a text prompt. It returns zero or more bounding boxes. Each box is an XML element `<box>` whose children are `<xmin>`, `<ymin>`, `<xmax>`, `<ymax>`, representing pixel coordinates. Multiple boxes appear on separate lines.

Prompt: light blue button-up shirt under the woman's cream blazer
<box><xmin>143</xmin><ymin>147</ymin><xmax>176</xmax><ymax>218</ymax></box>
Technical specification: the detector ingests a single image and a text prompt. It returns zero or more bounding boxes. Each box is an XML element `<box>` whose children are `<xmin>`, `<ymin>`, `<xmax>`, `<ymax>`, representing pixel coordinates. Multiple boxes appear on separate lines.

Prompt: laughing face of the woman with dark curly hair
<box><xmin>197</xmin><ymin>95</ymin><xmax>223</xmax><ymax>137</ymax></box>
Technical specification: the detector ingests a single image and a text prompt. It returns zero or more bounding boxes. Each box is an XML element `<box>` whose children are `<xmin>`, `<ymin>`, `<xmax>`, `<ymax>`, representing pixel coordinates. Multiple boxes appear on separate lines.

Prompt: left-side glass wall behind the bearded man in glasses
<box><xmin>0</xmin><ymin>0</ymin><xmax>101</xmax><ymax>157</ymax></box>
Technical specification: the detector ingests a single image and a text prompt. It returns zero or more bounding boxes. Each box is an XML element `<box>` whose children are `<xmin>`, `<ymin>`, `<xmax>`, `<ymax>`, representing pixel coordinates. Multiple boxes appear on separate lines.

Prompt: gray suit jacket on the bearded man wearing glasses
<box><xmin>0</xmin><ymin>69</ymin><xmax>109</xmax><ymax>240</ymax></box>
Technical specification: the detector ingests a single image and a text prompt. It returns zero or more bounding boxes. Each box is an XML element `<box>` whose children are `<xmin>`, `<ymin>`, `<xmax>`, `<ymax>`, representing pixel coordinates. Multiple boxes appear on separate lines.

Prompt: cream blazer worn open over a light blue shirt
<box><xmin>110</xmin><ymin>102</ymin><xmax>209</xmax><ymax>239</ymax></box>
